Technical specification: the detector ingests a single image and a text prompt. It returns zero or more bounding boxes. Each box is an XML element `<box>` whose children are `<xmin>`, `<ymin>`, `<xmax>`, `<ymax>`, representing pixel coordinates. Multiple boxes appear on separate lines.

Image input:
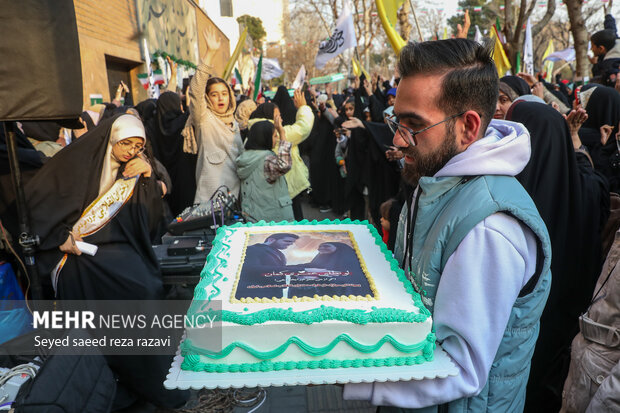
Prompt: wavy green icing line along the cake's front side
<box><xmin>183</xmin><ymin>334</ymin><xmax>434</xmax><ymax>360</ymax></box>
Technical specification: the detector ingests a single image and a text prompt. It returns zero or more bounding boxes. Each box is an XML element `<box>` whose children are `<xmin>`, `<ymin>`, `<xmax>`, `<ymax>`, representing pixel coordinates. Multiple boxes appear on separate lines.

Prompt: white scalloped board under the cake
<box><xmin>164</xmin><ymin>345</ymin><xmax>458</xmax><ymax>390</ymax></box>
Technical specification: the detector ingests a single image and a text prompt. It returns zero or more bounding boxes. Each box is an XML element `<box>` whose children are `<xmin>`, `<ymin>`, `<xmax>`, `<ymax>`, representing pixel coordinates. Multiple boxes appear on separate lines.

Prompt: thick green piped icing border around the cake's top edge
<box><xmin>188</xmin><ymin>218</ymin><xmax>431</xmax><ymax>325</ymax></box>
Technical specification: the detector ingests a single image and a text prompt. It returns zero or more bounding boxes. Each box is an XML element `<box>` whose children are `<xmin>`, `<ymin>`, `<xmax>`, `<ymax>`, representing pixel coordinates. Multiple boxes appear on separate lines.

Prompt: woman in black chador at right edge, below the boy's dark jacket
<box><xmin>579</xmin><ymin>85</ymin><xmax>620</xmax><ymax>193</ymax></box>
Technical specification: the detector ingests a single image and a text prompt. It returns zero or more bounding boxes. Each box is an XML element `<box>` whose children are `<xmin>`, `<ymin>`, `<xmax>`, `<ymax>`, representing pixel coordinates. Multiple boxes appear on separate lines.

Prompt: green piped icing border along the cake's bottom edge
<box><xmin>181</xmin><ymin>333</ymin><xmax>436</xmax><ymax>373</ymax></box>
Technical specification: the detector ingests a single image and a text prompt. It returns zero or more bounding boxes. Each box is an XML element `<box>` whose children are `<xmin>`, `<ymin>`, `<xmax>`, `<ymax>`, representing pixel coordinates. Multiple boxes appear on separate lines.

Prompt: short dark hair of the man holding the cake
<box><xmin>398</xmin><ymin>39</ymin><xmax>499</xmax><ymax>131</ymax></box>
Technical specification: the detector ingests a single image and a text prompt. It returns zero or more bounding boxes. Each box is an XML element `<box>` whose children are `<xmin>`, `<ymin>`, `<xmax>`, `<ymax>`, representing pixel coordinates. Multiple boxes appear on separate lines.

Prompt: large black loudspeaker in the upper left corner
<box><xmin>0</xmin><ymin>0</ymin><xmax>83</xmax><ymax>121</ymax></box>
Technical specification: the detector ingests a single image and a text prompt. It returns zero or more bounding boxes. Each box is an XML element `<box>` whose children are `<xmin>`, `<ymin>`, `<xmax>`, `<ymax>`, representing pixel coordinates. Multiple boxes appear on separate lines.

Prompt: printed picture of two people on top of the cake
<box><xmin>234</xmin><ymin>231</ymin><xmax>374</xmax><ymax>300</ymax></box>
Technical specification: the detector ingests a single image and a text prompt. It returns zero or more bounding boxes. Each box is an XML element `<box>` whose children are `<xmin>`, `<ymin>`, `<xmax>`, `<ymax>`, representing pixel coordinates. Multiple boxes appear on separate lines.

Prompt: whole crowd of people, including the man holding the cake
<box><xmin>0</xmin><ymin>8</ymin><xmax>620</xmax><ymax>412</ymax></box>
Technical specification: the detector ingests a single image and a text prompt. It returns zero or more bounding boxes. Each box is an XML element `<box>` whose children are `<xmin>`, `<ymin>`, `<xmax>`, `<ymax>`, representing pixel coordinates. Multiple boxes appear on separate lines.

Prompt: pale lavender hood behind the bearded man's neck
<box><xmin>435</xmin><ymin>119</ymin><xmax>532</xmax><ymax>178</ymax></box>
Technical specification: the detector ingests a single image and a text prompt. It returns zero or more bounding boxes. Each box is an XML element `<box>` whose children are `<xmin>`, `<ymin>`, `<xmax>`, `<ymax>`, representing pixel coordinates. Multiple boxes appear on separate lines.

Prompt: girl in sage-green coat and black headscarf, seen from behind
<box><xmin>237</xmin><ymin>114</ymin><xmax>295</xmax><ymax>222</ymax></box>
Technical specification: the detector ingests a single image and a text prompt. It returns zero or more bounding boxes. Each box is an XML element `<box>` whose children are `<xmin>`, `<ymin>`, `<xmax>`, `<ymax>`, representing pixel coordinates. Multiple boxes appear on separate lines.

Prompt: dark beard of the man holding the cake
<box><xmin>402</xmin><ymin>122</ymin><xmax>459</xmax><ymax>186</ymax></box>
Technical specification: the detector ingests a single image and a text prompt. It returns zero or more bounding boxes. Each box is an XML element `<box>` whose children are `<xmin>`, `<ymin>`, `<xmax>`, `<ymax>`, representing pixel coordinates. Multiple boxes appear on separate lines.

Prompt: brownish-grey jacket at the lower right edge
<box><xmin>561</xmin><ymin>230</ymin><xmax>620</xmax><ymax>413</ymax></box>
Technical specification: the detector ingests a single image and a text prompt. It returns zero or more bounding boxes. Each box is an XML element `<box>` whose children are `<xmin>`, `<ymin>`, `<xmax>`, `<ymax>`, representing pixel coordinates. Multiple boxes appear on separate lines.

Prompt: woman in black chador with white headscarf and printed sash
<box><xmin>26</xmin><ymin>115</ymin><xmax>187</xmax><ymax>408</ymax></box>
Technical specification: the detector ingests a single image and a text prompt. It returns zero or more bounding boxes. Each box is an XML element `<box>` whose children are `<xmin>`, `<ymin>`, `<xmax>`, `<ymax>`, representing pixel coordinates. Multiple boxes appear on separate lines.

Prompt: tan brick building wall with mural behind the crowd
<box><xmin>74</xmin><ymin>0</ymin><xmax>230</xmax><ymax>108</ymax></box>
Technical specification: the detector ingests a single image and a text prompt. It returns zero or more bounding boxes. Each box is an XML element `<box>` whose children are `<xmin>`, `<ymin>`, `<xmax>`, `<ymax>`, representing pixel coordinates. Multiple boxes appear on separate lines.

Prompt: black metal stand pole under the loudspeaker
<box><xmin>4</xmin><ymin>122</ymin><xmax>43</xmax><ymax>300</ymax></box>
